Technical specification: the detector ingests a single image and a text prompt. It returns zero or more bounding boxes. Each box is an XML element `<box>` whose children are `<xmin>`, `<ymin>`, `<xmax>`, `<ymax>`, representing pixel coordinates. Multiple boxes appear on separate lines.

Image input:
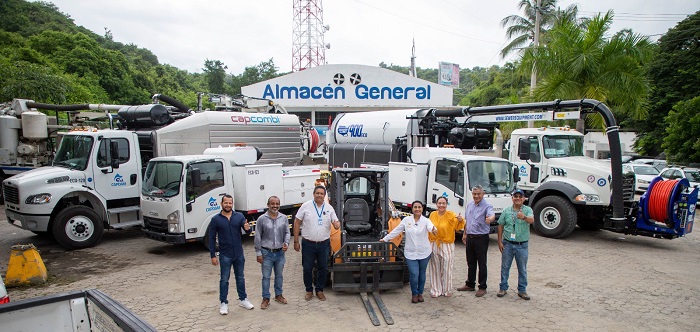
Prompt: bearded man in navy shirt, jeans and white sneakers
<box><xmin>209</xmin><ymin>194</ymin><xmax>255</xmax><ymax>315</ymax></box>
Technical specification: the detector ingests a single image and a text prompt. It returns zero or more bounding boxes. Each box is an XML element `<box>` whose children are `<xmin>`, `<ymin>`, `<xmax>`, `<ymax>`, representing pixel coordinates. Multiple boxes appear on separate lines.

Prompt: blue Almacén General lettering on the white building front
<box><xmin>262</xmin><ymin>73</ymin><xmax>431</xmax><ymax>100</ymax></box>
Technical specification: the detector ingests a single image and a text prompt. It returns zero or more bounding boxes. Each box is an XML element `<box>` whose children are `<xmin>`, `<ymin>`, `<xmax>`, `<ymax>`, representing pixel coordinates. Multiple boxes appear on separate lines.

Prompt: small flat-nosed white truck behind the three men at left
<box><xmin>141</xmin><ymin>147</ymin><xmax>321</xmax><ymax>247</ymax></box>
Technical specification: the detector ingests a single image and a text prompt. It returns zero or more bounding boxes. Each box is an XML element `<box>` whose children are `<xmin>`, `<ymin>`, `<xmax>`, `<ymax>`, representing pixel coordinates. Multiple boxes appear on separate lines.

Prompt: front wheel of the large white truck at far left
<box><xmin>52</xmin><ymin>205</ymin><xmax>104</xmax><ymax>249</ymax></box>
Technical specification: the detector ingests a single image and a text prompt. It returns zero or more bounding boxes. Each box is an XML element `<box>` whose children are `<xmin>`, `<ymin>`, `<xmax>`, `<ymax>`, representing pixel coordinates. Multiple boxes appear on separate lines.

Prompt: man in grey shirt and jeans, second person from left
<box><xmin>255</xmin><ymin>196</ymin><xmax>290</xmax><ymax>310</ymax></box>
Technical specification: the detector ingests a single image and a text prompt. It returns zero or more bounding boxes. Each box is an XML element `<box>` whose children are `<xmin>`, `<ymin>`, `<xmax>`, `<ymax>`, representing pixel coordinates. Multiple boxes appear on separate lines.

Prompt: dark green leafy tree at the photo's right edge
<box><xmin>636</xmin><ymin>11</ymin><xmax>700</xmax><ymax>161</ymax></box>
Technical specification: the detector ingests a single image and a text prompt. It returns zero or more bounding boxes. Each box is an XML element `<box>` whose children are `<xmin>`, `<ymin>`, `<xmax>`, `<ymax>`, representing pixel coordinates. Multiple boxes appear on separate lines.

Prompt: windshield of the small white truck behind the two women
<box><xmin>467</xmin><ymin>160</ymin><xmax>514</xmax><ymax>194</ymax></box>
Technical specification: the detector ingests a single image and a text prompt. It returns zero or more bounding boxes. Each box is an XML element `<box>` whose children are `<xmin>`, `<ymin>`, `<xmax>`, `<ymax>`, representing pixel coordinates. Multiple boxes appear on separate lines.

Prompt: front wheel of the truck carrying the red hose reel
<box><xmin>533</xmin><ymin>196</ymin><xmax>577</xmax><ymax>239</ymax></box>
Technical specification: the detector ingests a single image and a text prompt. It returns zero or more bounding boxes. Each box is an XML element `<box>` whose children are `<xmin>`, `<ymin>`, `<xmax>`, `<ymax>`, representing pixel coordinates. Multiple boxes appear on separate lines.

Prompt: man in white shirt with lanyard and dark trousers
<box><xmin>294</xmin><ymin>186</ymin><xmax>340</xmax><ymax>301</ymax></box>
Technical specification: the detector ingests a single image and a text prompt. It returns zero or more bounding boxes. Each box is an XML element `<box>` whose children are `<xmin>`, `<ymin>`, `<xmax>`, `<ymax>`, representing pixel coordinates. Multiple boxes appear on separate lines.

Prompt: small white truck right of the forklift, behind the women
<box><xmin>388</xmin><ymin>147</ymin><xmax>517</xmax><ymax>227</ymax></box>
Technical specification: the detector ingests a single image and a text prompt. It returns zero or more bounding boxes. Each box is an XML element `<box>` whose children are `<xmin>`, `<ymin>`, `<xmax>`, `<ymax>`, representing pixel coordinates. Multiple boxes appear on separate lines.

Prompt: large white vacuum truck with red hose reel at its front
<box><xmin>326</xmin><ymin>99</ymin><xmax>695</xmax><ymax>238</ymax></box>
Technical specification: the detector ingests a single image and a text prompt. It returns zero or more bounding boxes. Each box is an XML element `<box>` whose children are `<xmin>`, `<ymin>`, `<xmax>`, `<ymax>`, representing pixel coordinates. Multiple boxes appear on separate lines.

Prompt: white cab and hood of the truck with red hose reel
<box><xmin>508</xmin><ymin>127</ymin><xmax>634</xmax><ymax>237</ymax></box>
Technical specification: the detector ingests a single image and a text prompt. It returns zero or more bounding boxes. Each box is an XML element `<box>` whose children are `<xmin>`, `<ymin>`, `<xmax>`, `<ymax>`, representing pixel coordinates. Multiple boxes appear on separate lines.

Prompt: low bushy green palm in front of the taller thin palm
<box><xmin>520</xmin><ymin>11</ymin><xmax>654</xmax><ymax>126</ymax></box>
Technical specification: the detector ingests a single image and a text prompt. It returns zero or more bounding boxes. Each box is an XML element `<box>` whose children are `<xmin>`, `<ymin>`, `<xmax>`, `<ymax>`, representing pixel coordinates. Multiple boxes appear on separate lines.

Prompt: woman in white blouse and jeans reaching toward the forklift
<box><xmin>379</xmin><ymin>201</ymin><xmax>437</xmax><ymax>303</ymax></box>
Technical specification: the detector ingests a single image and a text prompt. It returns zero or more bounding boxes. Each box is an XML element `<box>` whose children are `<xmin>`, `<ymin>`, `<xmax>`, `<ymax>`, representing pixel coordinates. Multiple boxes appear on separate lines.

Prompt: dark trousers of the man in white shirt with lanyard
<box><xmin>301</xmin><ymin>240</ymin><xmax>331</xmax><ymax>292</ymax></box>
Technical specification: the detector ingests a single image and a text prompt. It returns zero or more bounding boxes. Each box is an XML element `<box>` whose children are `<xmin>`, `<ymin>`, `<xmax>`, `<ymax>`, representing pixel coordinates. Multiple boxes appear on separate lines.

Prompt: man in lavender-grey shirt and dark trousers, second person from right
<box><xmin>457</xmin><ymin>186</ymin><xmax>496</xmax><ymax>297</ymax></box>
